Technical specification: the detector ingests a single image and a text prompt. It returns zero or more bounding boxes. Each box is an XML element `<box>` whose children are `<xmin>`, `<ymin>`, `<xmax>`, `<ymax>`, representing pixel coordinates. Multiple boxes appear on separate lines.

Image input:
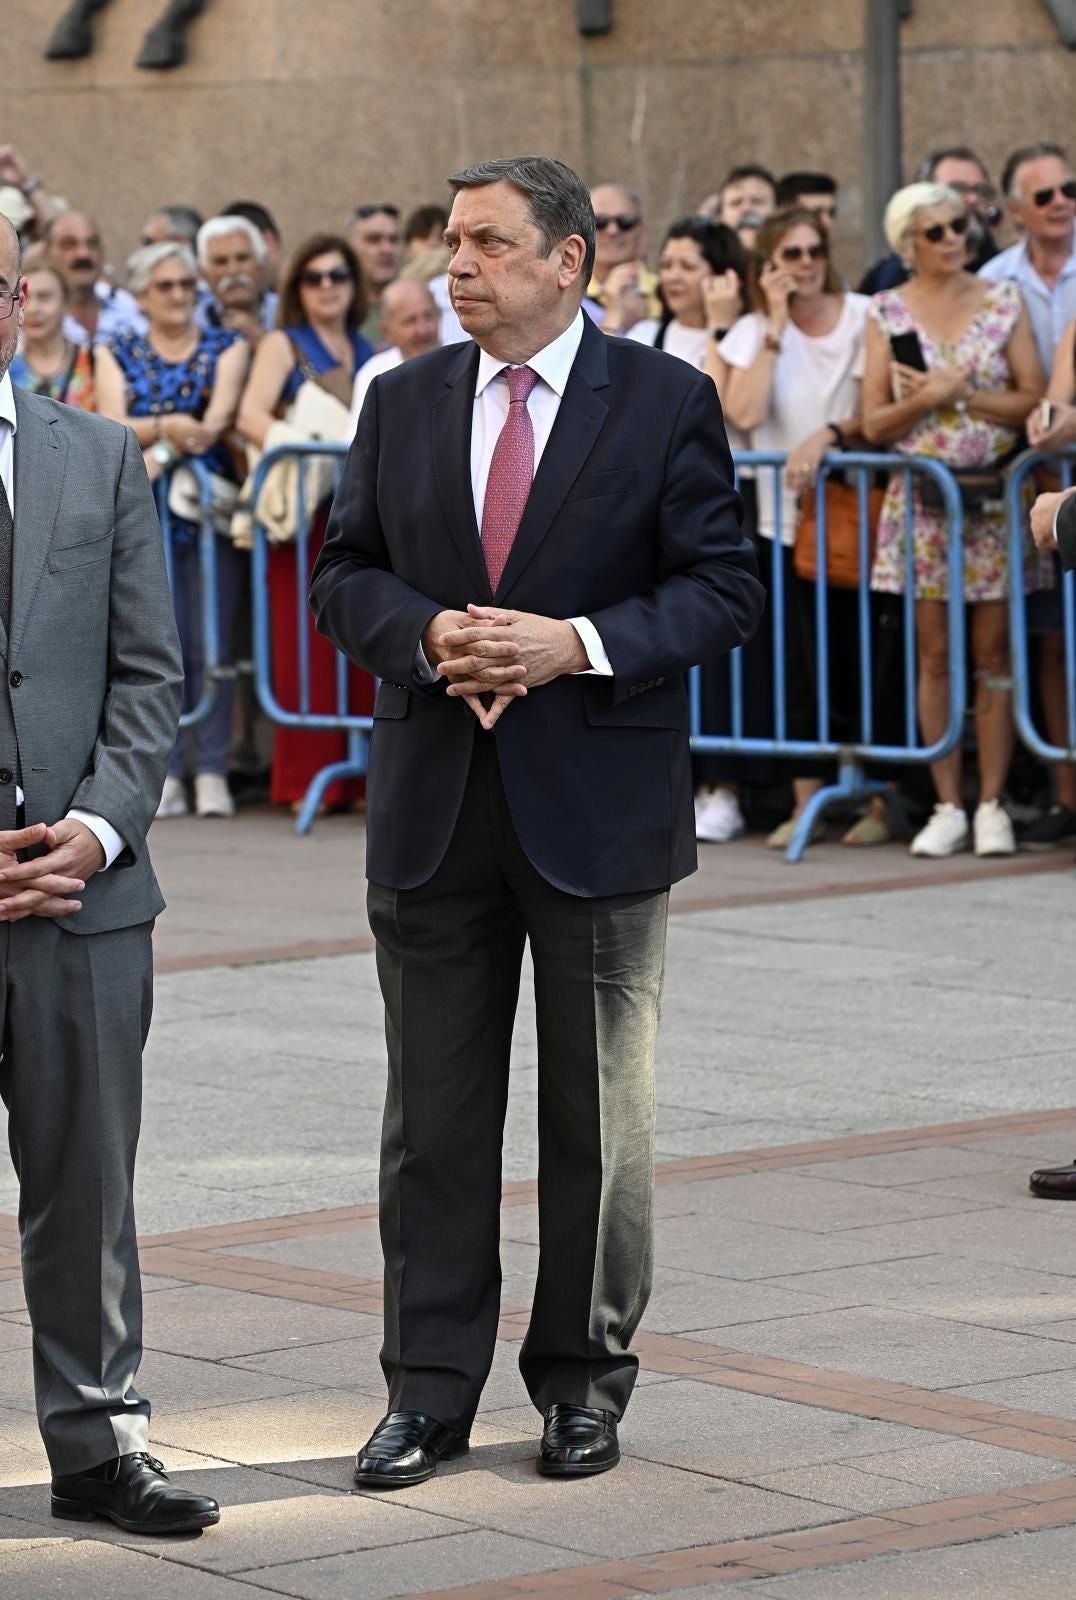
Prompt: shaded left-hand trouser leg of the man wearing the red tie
<box><xmin>368</xmin><ymin>733</ymin><xmax>524</xmax><ymax>1434</ymax></box>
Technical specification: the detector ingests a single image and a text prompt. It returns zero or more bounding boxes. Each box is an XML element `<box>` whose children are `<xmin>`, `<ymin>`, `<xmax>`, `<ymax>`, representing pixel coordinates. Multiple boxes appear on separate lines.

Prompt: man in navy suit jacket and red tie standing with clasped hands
<box><xmin>312</xmin><ymin>157</ymin><xmax>762</xmax><ymax>1488</ymax></box>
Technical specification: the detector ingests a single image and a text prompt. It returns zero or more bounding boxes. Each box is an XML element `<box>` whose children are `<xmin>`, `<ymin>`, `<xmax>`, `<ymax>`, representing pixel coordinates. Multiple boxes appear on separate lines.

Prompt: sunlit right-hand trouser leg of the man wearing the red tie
<box><xmin>517</xmin><ymin>862</ymin><xmax>669</xmax><ymax>1416</ymax></box>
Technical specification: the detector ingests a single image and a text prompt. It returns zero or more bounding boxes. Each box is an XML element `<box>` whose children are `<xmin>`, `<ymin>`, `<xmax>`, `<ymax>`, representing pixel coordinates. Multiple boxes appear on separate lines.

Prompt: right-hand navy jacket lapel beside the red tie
<box><xmin>496</xmin><ymin>314</ymin><xmax>608</xmax><ymax>605</ymax></box>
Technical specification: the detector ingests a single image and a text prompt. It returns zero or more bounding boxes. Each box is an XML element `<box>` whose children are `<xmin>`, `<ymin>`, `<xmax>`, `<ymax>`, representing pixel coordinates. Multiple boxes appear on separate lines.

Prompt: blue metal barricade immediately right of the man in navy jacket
<box><xmin>690</xmin><ymin>451</ymin><xmax>966</xmax><ymax>861</ymax></box>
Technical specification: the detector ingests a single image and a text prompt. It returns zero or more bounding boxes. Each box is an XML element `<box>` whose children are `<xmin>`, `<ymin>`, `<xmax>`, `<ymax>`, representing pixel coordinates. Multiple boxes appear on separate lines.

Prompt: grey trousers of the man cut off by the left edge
<box><xmin>0</xmin><ymin>917</ymin><xmax>152</xmax><ymax>1474</ymax></box>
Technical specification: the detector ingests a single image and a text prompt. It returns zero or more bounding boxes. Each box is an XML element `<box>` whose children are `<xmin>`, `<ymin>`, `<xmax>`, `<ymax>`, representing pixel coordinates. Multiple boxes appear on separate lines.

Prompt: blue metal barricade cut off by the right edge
<box><xmin>1009</xmin><ymin>450</ymin><xmax>1076</xmax><ymax>762</ymax></box>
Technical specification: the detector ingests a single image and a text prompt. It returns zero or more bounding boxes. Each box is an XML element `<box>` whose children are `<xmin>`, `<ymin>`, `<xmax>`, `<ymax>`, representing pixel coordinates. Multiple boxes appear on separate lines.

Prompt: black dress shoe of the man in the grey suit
<box><xmin>53</xmin><ymin>1450</ymin><xmax>221</xmax><ymax>1533</ymax></box>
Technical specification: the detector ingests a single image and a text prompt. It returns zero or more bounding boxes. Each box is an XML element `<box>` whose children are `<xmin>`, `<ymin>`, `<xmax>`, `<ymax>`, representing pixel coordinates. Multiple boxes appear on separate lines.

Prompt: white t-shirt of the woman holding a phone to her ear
<box><xmin>719</xmin><ymin>294</ymin><xmax>869</xmax><ymax>546</ymax></box>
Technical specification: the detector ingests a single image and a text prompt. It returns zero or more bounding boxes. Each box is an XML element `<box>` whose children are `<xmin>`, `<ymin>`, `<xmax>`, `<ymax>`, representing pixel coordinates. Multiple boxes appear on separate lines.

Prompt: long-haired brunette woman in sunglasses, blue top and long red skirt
<box><xmin>239</xmin><ymin>234</ymin><xmax>373</xmax><ymax>810</ymax></box>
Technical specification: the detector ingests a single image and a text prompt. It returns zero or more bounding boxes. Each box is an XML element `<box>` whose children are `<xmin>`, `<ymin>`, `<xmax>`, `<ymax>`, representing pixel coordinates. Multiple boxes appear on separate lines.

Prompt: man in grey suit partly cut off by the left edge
<box><xmin>0</xmin><ymin>218</ymin><xmax>219</xmax><ymax>1533</ymax></box>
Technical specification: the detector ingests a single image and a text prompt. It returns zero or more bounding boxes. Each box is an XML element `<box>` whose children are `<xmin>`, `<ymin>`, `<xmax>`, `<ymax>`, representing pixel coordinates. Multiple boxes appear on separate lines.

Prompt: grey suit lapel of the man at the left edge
<box><xmin>5</xmin><ymin>389</ymin><xmax>67</xmax><ymax>656</ymax></box>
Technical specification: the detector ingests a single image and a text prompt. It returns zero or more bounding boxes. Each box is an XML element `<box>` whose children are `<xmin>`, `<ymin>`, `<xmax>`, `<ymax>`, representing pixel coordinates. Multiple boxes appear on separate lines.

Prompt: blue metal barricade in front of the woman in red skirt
<box><xmin>251</xmin><ymin>440</ymin><xmax>365</xmax><ymax>834</ymax></box>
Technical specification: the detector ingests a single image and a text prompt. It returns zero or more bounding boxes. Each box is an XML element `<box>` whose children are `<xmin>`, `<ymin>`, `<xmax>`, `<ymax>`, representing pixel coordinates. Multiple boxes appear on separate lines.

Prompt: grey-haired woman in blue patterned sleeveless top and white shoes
<box><xmin>96</xmin><ymin>243</ymin><xmax>250</xmax><ymax>818</ymax></box>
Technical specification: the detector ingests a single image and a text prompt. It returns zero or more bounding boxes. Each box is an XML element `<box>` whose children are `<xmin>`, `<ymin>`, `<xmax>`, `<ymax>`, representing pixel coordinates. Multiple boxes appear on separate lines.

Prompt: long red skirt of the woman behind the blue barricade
<box><xmin>269</xmin><ymin>510</ymin><xmax>373</xmax><ymax>806</ymax></box>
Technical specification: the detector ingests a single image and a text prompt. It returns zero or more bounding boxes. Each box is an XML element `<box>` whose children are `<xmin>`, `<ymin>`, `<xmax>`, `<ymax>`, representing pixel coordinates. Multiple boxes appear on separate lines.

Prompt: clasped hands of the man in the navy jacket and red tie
<box><xmin>423</xmin><ymin>605</ymin><xmax>591</xmax><ymax>733</ymax></box>
